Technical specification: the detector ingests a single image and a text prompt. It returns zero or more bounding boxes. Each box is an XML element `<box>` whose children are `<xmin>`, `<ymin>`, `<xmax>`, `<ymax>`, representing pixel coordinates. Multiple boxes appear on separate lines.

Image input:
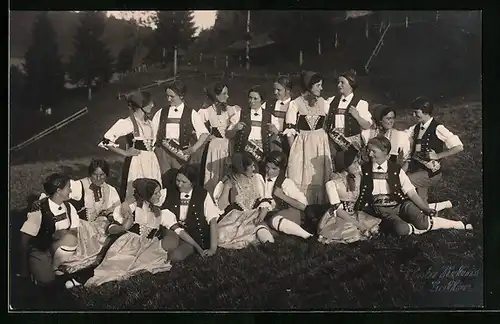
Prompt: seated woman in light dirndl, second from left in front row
<box><xmin>40</xmin><ymin>159</ymin><xmax>120</xmax><ymax>273</ymax></box>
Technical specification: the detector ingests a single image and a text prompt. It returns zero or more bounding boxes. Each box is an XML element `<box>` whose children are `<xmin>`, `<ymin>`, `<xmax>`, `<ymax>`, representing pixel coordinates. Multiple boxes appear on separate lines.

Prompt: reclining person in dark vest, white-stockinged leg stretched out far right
<box><xmin>354</xmin><ymin>136</ymin><xmax>472</xmax><ymax>235</ymax></box>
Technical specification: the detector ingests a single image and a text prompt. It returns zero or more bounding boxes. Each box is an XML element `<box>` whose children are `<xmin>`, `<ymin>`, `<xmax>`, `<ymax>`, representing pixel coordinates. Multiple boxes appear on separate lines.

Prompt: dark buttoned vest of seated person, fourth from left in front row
<box><xmin>161</xmin><ymin>185</ymin><xmax>211</xmax><ymax>249</ymax></box>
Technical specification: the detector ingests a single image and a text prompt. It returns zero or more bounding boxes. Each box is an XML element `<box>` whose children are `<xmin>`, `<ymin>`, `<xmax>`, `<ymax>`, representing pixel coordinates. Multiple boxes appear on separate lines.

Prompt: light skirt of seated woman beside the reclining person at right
<box><xmin>318</xmin><ymin>209</ymin><xmax>381</xmax><ymax>244</ymax></box>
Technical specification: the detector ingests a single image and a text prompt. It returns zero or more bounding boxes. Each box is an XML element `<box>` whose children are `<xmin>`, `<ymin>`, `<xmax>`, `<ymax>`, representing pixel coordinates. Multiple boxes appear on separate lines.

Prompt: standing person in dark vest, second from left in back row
<box><xmin>152</xmin><ymin>80</ymin><xmax>209</xmax><ymax>186</ymax></box>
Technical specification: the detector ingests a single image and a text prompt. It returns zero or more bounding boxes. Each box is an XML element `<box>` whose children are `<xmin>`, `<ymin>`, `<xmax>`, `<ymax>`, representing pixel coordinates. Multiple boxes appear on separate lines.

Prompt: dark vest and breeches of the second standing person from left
<box><xmin>155</xmin><ymin>104</ymin><xmax>196</xmax><ymax>180</ymax></box>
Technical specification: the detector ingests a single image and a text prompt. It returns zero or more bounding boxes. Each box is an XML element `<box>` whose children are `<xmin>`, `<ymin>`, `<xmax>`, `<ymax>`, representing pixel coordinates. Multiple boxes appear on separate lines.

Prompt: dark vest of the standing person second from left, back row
<box><xmin>156</xmin><ymin>104</ymin><xmax>194</xmax><ymax>148</ymax></box>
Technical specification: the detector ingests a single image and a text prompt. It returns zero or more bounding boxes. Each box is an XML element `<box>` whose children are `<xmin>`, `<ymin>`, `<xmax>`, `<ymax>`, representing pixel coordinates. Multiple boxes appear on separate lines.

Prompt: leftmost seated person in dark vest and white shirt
<box><xmin>18</xmin><ymin>173</ymin><xmax>80</xmax><ymax>286</ymax></box>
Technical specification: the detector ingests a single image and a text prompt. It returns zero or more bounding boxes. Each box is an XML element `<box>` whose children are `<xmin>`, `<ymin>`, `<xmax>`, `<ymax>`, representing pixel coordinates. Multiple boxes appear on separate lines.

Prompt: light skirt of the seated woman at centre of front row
<box><xmin>217</xmin><ymin>208</ymin><xmax>267</xmax><ymax>249</ymax></box>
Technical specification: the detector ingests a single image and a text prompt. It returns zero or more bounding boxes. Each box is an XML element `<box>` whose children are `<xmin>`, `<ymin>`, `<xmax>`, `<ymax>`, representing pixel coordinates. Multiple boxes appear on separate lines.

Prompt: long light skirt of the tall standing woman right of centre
<box><xmin>287</xmin><ymin>129</ymin><xmax>333</xmax><ymax>204</ymax></box>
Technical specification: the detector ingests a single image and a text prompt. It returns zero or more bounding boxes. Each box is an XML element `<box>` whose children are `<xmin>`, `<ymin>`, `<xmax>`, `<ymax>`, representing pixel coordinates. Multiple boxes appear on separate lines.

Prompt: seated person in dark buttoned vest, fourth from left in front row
<box><xmin>122</xmin><ymin>165</ymin><xmax>220</xmax><ymax>262</ymax></box>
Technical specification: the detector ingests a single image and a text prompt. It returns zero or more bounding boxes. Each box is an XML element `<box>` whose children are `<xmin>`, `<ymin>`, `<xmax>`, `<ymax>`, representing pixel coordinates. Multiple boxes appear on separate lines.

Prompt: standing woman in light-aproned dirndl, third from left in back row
<box><xmin>198</xmin><ymin>82</ymin><xmax>240</xmax><ymax>194</ymax></box>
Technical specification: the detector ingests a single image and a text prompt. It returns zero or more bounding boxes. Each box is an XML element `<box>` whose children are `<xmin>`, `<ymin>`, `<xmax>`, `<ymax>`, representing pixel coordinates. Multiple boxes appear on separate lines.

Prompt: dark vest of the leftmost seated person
<box><xmin>31</xmin><ymin>199</ymin><xmax>71</xmax><ymax>251</ymax></box>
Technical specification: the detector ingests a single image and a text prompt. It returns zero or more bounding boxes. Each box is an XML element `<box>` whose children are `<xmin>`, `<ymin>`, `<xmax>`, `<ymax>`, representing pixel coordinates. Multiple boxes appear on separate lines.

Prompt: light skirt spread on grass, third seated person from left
<box><xmin>85</xmin><ymin>232</ymin><xmax>172</xmax><ymax>287</ymax></box>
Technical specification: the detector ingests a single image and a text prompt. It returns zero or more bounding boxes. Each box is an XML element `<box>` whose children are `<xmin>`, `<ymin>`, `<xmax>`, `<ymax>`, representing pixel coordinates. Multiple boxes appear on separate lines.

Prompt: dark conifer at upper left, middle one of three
<box><xmin>70</xmin><ymin>11</ymin><xmax>113</xmax><ymax>88</ymax></box>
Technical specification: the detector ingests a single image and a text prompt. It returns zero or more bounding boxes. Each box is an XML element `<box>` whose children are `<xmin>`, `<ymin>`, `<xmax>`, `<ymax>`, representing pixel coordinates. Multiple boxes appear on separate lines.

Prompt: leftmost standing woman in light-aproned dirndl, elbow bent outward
<box><xmin>99</xmin><ymin>91</ymin><xmax>161</xmax><ymax>201</ymax></box>
